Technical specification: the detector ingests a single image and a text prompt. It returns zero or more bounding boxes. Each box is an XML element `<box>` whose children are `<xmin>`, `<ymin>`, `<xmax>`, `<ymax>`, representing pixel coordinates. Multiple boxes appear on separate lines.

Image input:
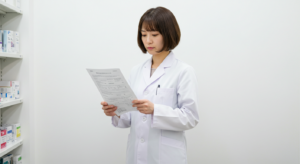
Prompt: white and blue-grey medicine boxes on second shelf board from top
<box><xmin>0</xmin><ymin>30</ymin><xmax>20</xmax><ymax>54</ymax></box>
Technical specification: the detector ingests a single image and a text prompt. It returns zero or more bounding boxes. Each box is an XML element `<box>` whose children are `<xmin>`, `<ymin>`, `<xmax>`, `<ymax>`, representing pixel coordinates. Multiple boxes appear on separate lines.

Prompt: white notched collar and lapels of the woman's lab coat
<box><xmin>143</xmin><ymin>51</ymin><xmax>176</xmax><ymax>88</ymax></box>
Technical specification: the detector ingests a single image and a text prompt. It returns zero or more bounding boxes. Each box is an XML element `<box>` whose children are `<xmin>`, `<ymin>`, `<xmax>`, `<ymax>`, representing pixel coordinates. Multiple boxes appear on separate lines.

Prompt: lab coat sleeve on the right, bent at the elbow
<box><xmin>151</xmin><ymin>67</ymin><xmax>199</xmax><ymax>131</ymax></box>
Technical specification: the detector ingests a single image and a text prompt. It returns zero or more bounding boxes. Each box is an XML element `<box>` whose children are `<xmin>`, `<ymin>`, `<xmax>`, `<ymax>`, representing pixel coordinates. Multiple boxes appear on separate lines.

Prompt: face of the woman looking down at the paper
<box><xmin>141</xmin><ymin>26</ymin><xmax>164</xmax><ymax>55</ymax></box>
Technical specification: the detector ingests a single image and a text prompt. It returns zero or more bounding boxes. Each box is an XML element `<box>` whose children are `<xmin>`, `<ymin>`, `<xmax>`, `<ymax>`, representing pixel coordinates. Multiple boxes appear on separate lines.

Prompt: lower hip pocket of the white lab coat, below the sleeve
<box><xmin>160</xmin><ymin>136</ymin><xmax>187</xmax><ymax>164</ymax></box>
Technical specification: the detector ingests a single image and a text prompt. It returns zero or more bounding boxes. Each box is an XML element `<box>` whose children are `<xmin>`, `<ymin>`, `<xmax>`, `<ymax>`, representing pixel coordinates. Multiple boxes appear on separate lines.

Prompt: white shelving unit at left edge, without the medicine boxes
<box><xmin>0</xmin><ymin>0</ymin><xmax>23</xmax><ymax>157</ymax></box>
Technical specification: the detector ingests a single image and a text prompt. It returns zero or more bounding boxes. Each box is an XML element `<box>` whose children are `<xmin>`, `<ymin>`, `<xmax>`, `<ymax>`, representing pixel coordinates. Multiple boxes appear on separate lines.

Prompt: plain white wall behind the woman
<box><xmin>34</xmin><ymin>0</ymin><xmax>300</xmax><ymax>164</ymax></box>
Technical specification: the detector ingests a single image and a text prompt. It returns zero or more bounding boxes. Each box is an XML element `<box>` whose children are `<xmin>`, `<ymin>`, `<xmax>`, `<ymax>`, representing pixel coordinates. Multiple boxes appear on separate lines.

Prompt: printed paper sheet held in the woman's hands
<box><xmin>87</xmin><ymin>68</ymin><xmax>138</xmax><ymax>116</ymax></box>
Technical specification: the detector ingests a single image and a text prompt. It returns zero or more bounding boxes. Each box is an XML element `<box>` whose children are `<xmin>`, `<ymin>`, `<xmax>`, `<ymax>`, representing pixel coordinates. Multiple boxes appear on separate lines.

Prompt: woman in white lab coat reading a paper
<box><xmin>101</xmin><ymin>7</ymin><xmax>199</xmax><ymax>164</ymax></box>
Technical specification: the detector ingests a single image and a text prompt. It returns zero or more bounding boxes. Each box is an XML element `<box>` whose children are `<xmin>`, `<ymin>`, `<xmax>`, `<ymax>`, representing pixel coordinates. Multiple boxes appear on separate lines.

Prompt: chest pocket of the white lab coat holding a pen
<box><xmin>155</xmin><ymin>88</ymin><xmax>175</xmax><ymax>107</ymax></box>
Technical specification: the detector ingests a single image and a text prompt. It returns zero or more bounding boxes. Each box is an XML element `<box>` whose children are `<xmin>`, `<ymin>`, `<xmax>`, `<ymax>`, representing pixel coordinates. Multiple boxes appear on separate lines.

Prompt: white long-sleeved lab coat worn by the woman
<box><xmin>112</xmin><ymin>52</ymin><xmax>199</xmax><ymax>164</ymax></box>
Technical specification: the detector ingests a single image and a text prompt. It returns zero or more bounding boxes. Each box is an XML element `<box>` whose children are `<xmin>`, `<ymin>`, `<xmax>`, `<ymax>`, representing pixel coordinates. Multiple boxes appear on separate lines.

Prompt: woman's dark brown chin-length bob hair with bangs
<box><xmin>137</xmin><ymin>7</ymin><xmax>181</xmax><ymax>53</ymax></box>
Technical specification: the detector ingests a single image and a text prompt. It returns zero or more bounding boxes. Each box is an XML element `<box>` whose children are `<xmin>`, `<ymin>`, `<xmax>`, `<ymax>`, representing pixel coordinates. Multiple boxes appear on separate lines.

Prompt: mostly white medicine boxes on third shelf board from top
<box><xmin>0</xmin><ymin>81</ymin><xmax>20</xmax><ymax>102</ymax></box>
